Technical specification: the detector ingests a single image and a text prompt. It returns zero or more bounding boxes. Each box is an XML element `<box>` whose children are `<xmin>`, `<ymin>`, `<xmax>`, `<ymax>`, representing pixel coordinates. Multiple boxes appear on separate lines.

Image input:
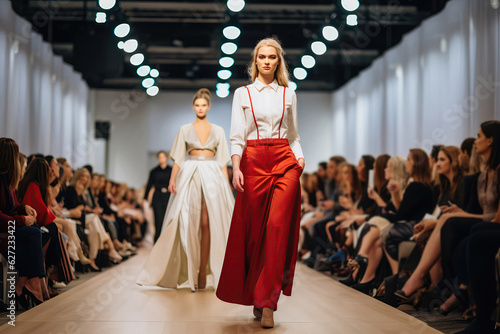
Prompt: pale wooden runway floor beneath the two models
<box><xmin>0</xmin><ymin>249</ymin><xmax>440</xmax><ymax>334</ymax></box>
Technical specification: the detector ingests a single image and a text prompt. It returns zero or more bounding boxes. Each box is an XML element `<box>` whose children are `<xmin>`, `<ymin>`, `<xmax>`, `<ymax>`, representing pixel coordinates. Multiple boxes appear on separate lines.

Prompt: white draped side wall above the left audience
<box><xmin>0</xmin><ymin>1</ymin><xmax>89</xmax><ymax>165</ymax></box>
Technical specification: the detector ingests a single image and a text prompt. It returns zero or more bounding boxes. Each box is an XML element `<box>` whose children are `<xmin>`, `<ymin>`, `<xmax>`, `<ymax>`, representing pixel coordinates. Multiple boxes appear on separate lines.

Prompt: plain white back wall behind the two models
<box><xmin>88</xmin><ymin>89</ymin><xmax>333</xmax><ymax>187</ymax></box>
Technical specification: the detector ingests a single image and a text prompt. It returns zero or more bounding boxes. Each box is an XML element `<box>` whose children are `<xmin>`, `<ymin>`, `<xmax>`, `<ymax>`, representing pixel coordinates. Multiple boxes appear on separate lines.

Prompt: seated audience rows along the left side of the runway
<box><xmin>0</xmin><ymin>138</ymin><xmax>147</xmax><ymax>309</ymax></box>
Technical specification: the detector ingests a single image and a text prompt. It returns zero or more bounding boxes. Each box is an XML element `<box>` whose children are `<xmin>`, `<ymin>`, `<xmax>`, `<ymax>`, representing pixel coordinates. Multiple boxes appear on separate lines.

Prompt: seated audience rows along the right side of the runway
<box><xmin>299</xmin><ymin>121</ymin><xmax>500</xmax><ymax>334</ymax></box>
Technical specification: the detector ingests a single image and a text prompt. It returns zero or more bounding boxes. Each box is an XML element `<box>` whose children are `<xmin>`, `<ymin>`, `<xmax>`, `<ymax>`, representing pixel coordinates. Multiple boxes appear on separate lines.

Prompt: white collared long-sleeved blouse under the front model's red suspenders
<box><xmin>229</xmin><ymin>79</ymin><xmax>304</xmax><ymax>160</ymax></box>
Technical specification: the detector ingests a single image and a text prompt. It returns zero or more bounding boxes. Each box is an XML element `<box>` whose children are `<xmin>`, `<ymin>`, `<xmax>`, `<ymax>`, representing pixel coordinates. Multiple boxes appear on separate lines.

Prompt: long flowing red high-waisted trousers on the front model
<box><xmin>216</xmin><ymin>139</ymin><xmax>302</xmax><ymax>310</ymax></box>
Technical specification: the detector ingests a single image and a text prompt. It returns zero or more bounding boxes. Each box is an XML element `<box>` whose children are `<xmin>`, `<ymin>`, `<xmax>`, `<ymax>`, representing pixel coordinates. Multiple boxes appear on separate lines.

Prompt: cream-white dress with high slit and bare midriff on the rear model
<box><xmin>137</xmin><ymin>90</ymin><xmax>234</xmax><ymax>291</ymax></box>
